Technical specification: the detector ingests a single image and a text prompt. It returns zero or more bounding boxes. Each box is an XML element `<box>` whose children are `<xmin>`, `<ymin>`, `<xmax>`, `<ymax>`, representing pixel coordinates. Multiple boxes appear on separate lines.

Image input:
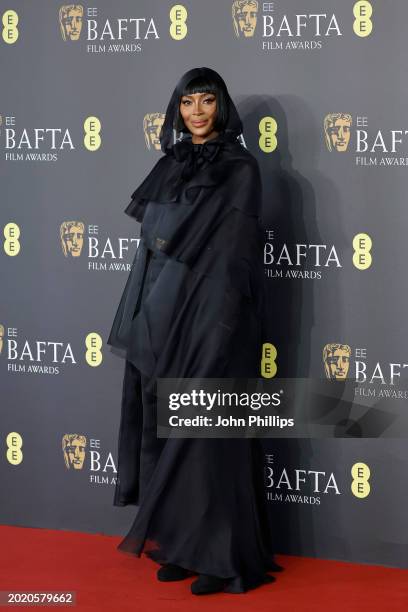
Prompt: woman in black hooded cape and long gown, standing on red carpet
<box><xmin>108</xmin><ymin>68</ymin><xmax>282</xmax><ymax>594</ymax></box>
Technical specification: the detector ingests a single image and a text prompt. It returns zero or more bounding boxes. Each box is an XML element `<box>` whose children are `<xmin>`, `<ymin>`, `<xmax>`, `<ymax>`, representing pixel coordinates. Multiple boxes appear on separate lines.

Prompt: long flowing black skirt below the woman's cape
<box><xmin>114</xmin><ymin>249</ymin><xmax>276</xmax><ymax>593</ymax></box>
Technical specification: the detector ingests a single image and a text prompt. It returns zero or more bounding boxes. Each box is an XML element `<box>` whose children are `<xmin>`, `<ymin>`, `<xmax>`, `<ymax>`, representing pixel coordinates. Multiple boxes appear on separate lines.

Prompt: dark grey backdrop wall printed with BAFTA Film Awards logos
<box><xmin>0</xmin><ymin>0</ymin><xmax>408</xmax><ymax>567</ymax></box>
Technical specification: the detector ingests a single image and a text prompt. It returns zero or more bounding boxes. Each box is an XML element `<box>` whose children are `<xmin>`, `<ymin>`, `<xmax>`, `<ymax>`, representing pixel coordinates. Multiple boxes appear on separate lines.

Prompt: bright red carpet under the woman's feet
<box><xmin>0</xmin><ymin>526</ymin><xmax>408</xmax><ymax>612</ymax></box>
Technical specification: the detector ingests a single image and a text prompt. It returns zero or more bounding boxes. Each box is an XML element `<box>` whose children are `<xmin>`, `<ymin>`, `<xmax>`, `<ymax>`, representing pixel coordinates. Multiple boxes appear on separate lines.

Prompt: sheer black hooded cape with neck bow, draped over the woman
<box><xmin>108</xmin><ymin>68</ymin><xmax>264</xmax><ymax>392</ymax></box>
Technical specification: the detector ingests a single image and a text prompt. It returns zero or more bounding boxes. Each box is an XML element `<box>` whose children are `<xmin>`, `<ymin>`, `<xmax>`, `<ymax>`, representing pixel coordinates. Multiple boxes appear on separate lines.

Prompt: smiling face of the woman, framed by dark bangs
<box><xmin>180</xmin><ymin>93</ymin><xmax>218</xmax><ymax>143</ymax></box>
